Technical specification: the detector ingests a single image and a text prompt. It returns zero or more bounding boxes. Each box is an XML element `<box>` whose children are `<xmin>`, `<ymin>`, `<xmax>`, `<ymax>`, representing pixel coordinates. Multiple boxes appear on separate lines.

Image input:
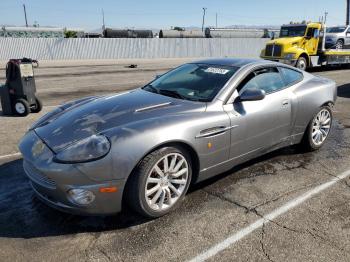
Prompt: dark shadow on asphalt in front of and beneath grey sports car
<box><xmin>0</xmin><ymin>143</ymin><xmax>312</xmax><ymax>238</ymax></box>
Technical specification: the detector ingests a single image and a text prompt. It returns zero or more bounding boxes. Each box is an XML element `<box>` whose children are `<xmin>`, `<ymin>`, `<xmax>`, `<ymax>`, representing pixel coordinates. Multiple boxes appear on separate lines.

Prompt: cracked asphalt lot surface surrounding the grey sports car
<box><xmin>0</xmin><ymin>59</ymin><xmax>350</xmax><ymax>261</ymax></box>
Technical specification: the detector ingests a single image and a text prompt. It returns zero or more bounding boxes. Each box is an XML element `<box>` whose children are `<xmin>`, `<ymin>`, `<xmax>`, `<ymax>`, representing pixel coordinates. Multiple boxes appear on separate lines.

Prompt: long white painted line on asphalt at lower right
<box><xmin>190</xmin><ymin>170</ymin><xmax>350</xmax><ymax>262</ymax></box>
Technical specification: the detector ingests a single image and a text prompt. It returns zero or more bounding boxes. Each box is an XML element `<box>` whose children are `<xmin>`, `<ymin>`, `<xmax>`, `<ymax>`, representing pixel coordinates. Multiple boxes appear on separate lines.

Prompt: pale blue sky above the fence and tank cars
<box><xmin>0</xmin><ymin>0</ymin><xmax>346</xmax><ymax>30</ymax></box>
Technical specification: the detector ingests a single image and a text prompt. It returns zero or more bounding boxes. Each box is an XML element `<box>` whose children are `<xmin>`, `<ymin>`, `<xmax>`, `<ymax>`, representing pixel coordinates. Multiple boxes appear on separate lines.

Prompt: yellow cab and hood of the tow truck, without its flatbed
<box><xmin>260</xmin><ymin>23</ymin><xmax>323</xmax><ymax>70</ymax></box>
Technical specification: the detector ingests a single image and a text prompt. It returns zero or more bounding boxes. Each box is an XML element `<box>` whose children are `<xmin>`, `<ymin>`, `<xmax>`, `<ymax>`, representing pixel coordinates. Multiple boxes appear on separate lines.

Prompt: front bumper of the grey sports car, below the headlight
<box><xmin>19</xmin><ymin>131</ymin><xmax>125</xmax><ymax>215</ymax></box>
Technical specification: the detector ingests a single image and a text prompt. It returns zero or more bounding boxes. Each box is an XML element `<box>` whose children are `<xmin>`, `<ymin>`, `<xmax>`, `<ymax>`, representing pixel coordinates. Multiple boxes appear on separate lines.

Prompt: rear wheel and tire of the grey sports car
<box><xmin>300</xmin><ymin>106</ymin><xmax>333</xmax><ymax>151</ymax></box>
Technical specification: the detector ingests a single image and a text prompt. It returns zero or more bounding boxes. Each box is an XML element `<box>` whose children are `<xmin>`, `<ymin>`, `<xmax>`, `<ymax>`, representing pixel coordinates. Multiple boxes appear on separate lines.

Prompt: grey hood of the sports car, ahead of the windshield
<box><xmin>32</xmin><ymin>89</ymin><xmax>206</xmax><ymax>153</ymax></box>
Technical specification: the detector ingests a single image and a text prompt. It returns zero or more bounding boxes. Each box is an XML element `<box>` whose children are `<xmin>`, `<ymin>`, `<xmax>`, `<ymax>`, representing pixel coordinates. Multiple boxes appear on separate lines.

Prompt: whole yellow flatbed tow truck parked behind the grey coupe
<box><xmin>260</xmin><ymin>23</ymin><xmax>350</xmax><ymax>70</ymax></box>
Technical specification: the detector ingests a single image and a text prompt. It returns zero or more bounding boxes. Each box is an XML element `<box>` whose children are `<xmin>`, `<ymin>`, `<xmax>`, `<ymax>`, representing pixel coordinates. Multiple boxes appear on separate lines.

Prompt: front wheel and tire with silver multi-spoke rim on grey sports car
<box><xmin>126</xmin><ymin>146</ymin><xmax>192</xmax><ymax>218</ymax></box>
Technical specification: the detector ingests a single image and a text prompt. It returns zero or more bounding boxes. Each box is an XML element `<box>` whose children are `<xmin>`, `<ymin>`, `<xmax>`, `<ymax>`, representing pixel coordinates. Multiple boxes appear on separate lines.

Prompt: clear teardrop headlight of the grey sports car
<box><xmin>54</xmin><ymin>135</ymin><xmax>111</xmax><ymax>163</ymax></box>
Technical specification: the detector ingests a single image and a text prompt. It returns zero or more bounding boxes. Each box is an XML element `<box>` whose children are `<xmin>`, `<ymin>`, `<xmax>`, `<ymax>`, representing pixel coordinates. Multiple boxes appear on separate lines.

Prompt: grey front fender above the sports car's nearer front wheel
<box><xmin>101</xmin><ymin>112</ymin><xmax>230</xmax><ymax>182</ymax></box>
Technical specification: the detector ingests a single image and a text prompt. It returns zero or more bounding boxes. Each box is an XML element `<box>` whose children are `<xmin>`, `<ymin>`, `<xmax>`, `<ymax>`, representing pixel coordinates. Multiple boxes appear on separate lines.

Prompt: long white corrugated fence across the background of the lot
<box><xmin>0</xmin><ymin>38</ymin><xmax>268</xmax><ymax>60</ymax></box>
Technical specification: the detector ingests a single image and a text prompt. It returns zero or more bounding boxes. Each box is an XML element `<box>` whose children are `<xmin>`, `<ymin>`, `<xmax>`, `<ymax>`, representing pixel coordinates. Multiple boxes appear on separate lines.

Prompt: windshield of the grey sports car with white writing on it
<box><xmin>143</xmin><ymin>64</ymin><xmax>238</xmax><ymax>102</ymax></box>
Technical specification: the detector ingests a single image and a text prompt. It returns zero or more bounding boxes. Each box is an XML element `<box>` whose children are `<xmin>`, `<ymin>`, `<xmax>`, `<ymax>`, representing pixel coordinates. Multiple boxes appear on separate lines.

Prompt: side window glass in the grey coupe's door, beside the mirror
<box><xmin>237</xmin><ymin>67</ymin><xmax>285</xmax><ymax>94</ymax></box>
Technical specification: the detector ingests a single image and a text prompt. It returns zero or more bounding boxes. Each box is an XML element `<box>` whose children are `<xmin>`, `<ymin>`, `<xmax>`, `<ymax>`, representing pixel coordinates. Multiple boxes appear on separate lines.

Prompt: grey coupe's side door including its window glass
<box><xmin>225</xmin><ymin>66</ymin><xmax>293</xmax><ymax>162</ymax></box>
